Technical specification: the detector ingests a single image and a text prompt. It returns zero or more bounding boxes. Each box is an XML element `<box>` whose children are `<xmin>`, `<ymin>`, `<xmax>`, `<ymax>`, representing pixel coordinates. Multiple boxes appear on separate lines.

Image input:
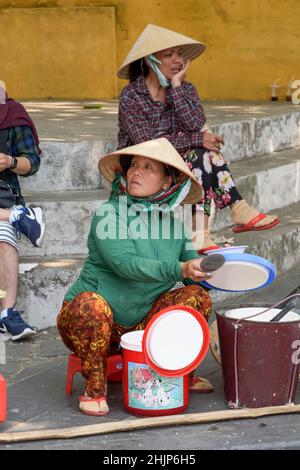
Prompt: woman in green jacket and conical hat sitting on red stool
<box><xmin>57</xmin><ymin>138</ymin><xmax>212</xmax><ymax>416</ymax></box>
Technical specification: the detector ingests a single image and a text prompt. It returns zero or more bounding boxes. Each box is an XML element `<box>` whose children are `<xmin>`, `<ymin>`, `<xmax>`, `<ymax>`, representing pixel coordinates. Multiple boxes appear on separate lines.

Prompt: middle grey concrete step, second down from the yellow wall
<box><xmin>21</xmin><ymin>148</ymin><xmax>300</xmax><ymax>256</ymax></box>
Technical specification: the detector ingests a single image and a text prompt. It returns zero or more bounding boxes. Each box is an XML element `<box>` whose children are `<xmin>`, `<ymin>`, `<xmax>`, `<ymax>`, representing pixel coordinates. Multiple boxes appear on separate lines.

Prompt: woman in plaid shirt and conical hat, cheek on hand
<box><xmin>118</xmin><ymin>24</ymin><xmax>279</xmax><ymax>250</ymax></box>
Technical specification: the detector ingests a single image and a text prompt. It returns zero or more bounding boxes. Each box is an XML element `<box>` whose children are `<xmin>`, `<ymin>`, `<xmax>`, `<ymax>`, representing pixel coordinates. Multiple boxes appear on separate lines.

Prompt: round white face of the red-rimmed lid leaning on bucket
<box><xmin>146</xmin><ymin>310</ymin><xmax>203</xmax><ymax>371</ymax></box>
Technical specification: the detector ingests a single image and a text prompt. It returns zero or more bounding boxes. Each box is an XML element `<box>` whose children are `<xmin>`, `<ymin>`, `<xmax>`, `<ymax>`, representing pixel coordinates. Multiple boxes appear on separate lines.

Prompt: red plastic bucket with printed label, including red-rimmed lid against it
<box><xmin>121</xmin><ymin>306</ymin><xmax>209</xmax><ymax>416</ymax></box>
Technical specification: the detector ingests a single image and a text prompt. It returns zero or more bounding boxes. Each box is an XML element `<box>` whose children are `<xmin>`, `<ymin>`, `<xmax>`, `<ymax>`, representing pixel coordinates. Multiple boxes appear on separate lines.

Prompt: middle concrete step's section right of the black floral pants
<box><xmin>211</xmin><ymin>147</ymin><xmax>300</xmax><ymax>231</ymax></box>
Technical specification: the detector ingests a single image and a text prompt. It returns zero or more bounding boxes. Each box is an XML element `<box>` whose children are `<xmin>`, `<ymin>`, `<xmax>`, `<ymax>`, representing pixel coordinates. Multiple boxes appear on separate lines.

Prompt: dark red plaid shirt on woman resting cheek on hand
<box><xmin>118</xmin><ymin>76</ymin><xmax>206</xmax><ymax>155</ymax></box>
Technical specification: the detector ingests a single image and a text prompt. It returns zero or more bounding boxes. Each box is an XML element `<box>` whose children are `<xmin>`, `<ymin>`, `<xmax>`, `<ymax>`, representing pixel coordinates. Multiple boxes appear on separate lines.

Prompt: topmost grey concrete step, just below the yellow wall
<box><xmin>21</xmin><ymin>102</ymin><xmax>300</xmax><ymax>192</ymax></box>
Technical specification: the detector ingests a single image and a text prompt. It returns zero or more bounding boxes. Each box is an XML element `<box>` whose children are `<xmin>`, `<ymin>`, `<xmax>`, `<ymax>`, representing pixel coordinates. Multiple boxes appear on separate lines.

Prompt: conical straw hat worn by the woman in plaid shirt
<box><xmin>118</xmin><ymin>24</ymin><xmax>206</xmax><ymax>78</ymax></box>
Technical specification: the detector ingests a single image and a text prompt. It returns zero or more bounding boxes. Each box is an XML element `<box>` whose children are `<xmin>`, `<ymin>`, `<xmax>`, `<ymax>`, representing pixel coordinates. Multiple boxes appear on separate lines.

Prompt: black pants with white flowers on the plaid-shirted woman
<box><xmin>185</xmin><ymin>147</ymin><xmax>243</xmax><ymax>216</ymax></box>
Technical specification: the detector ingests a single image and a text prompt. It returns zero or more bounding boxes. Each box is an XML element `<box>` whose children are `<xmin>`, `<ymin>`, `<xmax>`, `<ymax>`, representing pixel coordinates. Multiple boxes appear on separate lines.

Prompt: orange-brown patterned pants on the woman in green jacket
<box><xmin>57</xmin><ymin>285</ymin><xmax>211</xmax><ymax>398</ymax></box>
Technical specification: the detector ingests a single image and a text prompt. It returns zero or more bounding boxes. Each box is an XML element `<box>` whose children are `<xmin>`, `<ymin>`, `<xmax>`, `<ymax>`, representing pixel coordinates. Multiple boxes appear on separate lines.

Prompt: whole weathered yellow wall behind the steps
<box><xmin>0</xmin><ymin>0</ymin><xmax>300</xmax><ymax>100</ymax></box>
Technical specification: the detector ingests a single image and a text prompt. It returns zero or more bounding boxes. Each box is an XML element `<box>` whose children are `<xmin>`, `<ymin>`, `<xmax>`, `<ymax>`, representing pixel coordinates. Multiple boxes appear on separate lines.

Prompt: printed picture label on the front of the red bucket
<box><xmin>128</xmin><ymin>362</ymin><xmax>183</xmax><ymax>410</ymax></box>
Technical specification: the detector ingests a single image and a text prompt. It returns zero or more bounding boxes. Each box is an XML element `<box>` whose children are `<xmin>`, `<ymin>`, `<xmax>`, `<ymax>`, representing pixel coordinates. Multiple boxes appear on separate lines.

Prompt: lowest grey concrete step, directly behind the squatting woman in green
<box><xmin>18</xmin><ymin>203</ymin><xmax>300</xmax><ymax>329</ymax></box>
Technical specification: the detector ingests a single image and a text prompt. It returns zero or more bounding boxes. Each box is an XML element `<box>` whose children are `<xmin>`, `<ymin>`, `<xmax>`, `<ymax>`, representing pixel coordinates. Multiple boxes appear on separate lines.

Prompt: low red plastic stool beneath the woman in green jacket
<box><xmin>66</xmin><ymin>354</ymin><xmax>123</xmax><ymax>395</ymax></box>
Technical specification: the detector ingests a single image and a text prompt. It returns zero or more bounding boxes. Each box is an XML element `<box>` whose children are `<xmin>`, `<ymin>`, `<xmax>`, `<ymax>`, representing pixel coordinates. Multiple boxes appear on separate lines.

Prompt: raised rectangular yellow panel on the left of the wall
<box><xmin>0</xmin><ymin>7</ymin><xmax>117</xmax><ymax>99</ymax></box>
